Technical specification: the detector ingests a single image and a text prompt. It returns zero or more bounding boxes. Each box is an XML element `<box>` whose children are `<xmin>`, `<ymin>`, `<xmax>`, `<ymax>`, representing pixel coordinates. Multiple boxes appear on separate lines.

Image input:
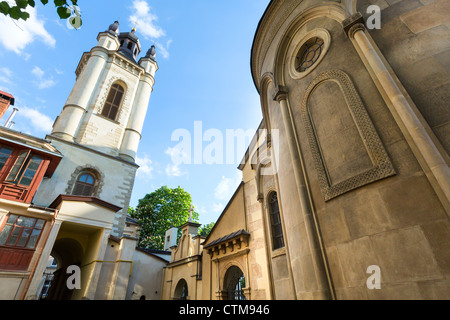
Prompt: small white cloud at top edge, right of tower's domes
<box><xmin>129</xmin><ymin>0</ymin><xmax>166</xmax><ymax>39</ymax></box>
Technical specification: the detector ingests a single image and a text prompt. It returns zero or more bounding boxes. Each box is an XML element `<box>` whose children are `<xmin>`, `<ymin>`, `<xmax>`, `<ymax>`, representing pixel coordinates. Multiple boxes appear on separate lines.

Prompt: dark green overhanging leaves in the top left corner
<box><xmin>0</xmin><ymin>0</ymin><xmax>82</xmax><ymax>29</ymax></box>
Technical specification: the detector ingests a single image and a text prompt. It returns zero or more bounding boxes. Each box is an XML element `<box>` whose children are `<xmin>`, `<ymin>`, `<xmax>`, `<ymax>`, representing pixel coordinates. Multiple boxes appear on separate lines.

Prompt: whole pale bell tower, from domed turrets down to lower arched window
<box><xmin>35</xmin><ymin>21</ymin><xmax>158</xmax><ymax>236</ymax></box>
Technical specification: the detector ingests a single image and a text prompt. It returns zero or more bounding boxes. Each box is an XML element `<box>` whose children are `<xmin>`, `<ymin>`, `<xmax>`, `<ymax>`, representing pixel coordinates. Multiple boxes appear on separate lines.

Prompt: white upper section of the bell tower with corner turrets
<box><xmin>51</xmin><ymin>22</ymin><xmax>158</xmax><ymax>162</ymax></box>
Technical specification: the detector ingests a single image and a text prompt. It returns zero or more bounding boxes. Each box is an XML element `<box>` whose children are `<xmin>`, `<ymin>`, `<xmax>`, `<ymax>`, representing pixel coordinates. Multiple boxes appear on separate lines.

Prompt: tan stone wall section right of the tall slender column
<box><xmin>357</xmin><ymin>0</ymin><xmax>450</xmax><ymax>154</ymax></box>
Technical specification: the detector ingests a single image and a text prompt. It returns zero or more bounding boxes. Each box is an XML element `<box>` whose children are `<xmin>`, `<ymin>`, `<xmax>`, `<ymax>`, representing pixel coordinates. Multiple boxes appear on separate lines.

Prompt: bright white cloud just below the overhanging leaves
<box><xmin>0</xmin><ymin>7</ymin><xmax>56</xmax><ymax>55</ymax></box>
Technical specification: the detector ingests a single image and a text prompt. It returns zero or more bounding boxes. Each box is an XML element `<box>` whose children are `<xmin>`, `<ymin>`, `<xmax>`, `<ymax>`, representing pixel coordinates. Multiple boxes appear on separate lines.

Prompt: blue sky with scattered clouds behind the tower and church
<box><xmin>0</xmin><ymin>0</ymin><xmax>269</xmax><ymax>223</ymax></box>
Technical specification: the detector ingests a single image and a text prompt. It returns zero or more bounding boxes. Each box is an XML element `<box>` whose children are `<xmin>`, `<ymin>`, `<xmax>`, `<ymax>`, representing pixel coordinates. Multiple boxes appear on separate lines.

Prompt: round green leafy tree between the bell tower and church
<box><xmin>130</xmin><ymin>186</ymin><xmax>199</xmax><ymax>250</ymax></box>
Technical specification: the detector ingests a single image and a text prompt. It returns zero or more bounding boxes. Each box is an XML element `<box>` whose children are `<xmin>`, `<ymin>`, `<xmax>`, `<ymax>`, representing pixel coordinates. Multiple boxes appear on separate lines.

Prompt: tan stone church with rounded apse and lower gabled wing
<box><xmin>163</xmin><ymin>0</ymin><xmax>450</xmax><ymax>300</ymax></box>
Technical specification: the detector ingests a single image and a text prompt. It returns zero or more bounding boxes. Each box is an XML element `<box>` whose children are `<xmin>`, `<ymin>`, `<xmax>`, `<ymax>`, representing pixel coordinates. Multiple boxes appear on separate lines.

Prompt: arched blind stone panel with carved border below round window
<box><xmin>301</xmin><ymin>70</ymin><xmax>395</xmax><ymax>201</ymax></box>
